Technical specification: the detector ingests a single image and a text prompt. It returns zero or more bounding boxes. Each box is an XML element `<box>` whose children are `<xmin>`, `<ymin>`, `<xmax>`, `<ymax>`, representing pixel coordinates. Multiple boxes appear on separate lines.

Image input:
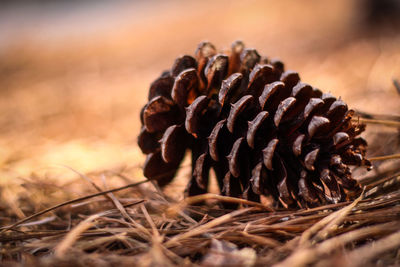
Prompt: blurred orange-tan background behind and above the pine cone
<box><xmin>0</xmin><ymin>0</ymin><xmax>400</xmax><ymax>197</ymax></box>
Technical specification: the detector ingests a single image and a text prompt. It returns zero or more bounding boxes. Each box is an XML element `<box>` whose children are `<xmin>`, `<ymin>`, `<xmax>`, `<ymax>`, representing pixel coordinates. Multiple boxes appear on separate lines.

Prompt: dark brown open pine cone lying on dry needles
<box><xmin>138</xmin><ymin>41</ymin><xmax>370</xmax><ymax>207</ymax></box>
